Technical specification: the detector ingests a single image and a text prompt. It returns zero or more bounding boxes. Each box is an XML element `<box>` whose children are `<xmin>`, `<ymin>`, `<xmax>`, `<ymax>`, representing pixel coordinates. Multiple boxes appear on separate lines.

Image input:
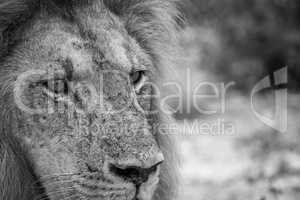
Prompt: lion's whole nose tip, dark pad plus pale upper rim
<box><xmin>110</xmin><ymin>154</ymin><xmax>164</xmax><ymax>186</ymax></box>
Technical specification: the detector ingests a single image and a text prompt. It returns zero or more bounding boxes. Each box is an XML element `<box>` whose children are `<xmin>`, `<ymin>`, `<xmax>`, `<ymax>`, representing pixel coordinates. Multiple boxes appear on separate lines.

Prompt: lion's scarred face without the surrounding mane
<box><xmin>9</xmin><ymin>5</ymin><xmax>164</xmax><ymax>200</ymax></box>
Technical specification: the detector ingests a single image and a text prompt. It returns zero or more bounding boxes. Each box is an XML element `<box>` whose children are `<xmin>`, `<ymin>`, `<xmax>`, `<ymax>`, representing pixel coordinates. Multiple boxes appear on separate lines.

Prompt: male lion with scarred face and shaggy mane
<box><xmin>0</xmin><ymin>0</ymin><xmax>182</xmax><ymax>200</ymax></box>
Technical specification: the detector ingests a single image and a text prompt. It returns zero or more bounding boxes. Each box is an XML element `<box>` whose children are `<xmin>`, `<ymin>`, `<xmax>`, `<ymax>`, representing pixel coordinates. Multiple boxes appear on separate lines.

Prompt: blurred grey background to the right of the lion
<box><xmin>167</xmin><ymin>0</ymin><xmax>300</xmax><ymax>200</ymax></box>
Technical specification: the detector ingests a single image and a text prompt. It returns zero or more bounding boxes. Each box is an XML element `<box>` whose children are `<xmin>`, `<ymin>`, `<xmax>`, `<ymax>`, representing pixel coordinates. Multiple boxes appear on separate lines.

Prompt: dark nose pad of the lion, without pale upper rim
<box><xmin>110</xmin><ymin>162</ymin><xmax>162</xmax><ymax>186</ymax></box>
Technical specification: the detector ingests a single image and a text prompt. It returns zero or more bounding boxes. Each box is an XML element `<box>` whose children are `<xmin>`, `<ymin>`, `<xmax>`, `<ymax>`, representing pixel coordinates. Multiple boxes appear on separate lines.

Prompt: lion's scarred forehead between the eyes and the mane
<box><xmin>20</xmin><ymin>10</ymin><xmax>151</xmax><ymax>72</ymax></box>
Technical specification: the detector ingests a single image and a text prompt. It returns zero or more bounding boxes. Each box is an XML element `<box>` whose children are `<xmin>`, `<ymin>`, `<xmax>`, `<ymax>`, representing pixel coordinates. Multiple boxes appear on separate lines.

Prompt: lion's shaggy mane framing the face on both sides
<box><xmin>0</xmin><ymin>0</ymin><xmax>181</xmax><ymax>200</ymax></box>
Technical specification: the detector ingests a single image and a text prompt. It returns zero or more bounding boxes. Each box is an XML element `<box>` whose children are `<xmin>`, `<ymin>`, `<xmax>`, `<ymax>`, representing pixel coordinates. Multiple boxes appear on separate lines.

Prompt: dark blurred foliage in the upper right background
<box><xmin>184</xmin><ymin>0</ymin><xmax>300</xmax><ymax>91</ymax></box>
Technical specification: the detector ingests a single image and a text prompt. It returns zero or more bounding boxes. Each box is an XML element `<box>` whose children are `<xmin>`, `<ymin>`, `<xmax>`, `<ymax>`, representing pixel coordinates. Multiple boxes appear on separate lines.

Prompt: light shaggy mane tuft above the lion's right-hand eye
<box><xmin>103</xmin><ymin>0</ymin><xmax>184</xmax><ymax>69</ymax></box>
